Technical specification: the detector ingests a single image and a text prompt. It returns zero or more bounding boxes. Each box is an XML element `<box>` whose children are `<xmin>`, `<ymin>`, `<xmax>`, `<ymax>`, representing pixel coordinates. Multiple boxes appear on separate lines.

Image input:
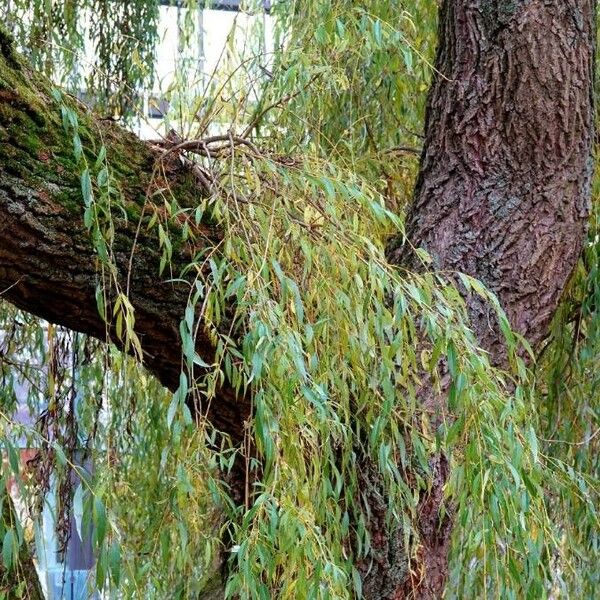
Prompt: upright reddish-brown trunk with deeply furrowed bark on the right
<box><xmin>388</xmin><ymin>0</ymin><xmax>595</xmax><ymax>598</ymax></box>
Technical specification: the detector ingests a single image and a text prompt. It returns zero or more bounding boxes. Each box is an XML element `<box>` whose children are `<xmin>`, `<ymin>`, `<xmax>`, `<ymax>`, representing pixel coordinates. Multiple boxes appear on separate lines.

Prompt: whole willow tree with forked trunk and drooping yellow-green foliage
<box><xmin>0</xmin><ymin>0</ymin><xmax>598</xmax><ymax>599</ymax></box>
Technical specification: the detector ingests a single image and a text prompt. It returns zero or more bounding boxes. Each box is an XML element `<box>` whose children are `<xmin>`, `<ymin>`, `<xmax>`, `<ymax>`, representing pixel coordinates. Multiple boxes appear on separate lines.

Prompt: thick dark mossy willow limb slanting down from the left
<box><xmin>0</xmin><ymin>30</ymin><xmax>249</xmax><ymax>443</ymax></box>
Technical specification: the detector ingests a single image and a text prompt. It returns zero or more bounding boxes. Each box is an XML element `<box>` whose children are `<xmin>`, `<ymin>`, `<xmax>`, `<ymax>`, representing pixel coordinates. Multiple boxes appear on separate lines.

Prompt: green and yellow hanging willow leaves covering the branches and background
<box><xmin>0</xmin><ymin>0</ymin><xmax>600</xmax><ymax>598</ymax></box>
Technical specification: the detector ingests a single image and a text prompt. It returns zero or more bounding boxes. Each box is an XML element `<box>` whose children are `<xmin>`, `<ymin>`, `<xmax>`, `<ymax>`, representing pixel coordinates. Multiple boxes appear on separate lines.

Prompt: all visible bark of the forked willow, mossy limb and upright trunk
<box><xmin>0</xmin><ymin>0</ymin><xmax>595</xmax><ymax>600</ymax></box>
